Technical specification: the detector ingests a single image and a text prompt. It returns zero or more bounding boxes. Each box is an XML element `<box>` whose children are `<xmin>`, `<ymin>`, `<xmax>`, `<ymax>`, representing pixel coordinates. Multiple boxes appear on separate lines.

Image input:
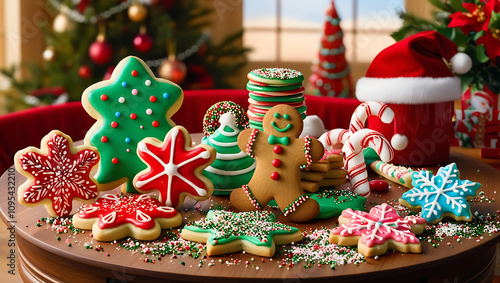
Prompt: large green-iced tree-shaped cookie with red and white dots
<box><xmin>82</xmin><ymin>57</ymin><xmax>183</xmax><ymax>192</ymax></box>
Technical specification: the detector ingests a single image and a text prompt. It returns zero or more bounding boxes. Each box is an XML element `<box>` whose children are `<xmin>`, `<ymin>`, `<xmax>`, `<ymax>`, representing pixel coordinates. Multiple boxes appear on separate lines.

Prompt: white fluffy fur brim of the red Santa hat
<box><xmin>356</xmin><ymin>77</ymin><xmax>462</xmax><ymax>104</ymax></box>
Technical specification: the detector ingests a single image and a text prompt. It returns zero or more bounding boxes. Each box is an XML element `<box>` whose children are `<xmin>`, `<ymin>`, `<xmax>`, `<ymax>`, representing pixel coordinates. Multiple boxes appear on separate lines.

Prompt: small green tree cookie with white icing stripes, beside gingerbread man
<box><xmin>202</xmin><ymin>113</ymin><xmax>255</xmax><ymax>195</ymax></box>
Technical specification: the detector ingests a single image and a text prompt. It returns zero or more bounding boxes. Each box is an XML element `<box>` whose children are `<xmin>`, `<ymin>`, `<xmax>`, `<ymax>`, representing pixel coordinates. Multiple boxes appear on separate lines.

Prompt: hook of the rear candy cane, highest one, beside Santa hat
<box><xmin>349</xmin><ymin>101</ymin><xmax>394</xmax><ymax>134</ymax></box>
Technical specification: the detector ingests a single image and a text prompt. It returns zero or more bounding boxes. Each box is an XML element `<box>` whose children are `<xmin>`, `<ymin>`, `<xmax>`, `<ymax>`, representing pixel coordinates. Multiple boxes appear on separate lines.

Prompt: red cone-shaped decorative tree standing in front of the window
<box><xmin>309</xmin><ymin>1</ymin><xmax>353</xmax><ymax>97</ymax></box>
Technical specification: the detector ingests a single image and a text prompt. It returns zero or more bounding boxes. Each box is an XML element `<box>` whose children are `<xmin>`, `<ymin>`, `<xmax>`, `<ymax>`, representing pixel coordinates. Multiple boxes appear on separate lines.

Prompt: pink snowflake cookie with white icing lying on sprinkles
<box><xmin>330</xmin><ymin>203</ymin><xmax>426</xmax><ymax>257</ymax></box>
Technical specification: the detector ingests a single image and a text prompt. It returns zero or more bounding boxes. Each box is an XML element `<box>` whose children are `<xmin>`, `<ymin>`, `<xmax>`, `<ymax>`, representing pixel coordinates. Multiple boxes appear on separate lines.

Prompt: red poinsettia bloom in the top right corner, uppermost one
<box><xmin>448</xmin><ymin>0</ymin><xmax>500</xmax><ymax>34</ymax></box>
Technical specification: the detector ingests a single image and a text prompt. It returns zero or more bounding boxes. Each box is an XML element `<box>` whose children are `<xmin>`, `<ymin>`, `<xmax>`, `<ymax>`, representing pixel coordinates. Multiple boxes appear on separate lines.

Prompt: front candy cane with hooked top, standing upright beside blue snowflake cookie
<box><xmin>342</xmin><ymin>129</ymin><xmax>394</xmax><ymax>197</ymax></box>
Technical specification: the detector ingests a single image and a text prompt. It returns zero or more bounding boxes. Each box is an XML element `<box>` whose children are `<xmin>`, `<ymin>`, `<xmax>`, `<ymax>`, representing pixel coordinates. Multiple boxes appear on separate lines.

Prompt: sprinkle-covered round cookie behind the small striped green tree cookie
<box><xmin>203</xmin><ymin>101</ymin><xmax>250</xmax><ymax>137</ymax></box>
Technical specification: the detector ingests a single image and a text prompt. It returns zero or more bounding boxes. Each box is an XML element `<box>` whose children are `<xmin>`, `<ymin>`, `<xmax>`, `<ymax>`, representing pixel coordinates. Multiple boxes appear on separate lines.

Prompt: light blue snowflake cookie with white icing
<box><xmin>399</xmin><ymin>163</ymin><xmax>481</xmax><ymax>223</ymax></box>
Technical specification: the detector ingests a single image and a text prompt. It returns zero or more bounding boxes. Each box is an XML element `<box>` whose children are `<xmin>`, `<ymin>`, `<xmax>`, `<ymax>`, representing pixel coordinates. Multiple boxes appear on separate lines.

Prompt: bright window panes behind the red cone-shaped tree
<box><xmin>243</xmin><ymin>0</ymin><xmax>405</xmax><ymax>64</ymax></box>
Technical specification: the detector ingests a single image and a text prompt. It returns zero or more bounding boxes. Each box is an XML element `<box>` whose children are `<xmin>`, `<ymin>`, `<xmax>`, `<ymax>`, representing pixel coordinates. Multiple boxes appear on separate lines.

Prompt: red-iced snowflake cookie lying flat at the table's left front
<box><xmin>73</xmin><ymin>194</ymin><xmax>182</xmax><ymax>241</ymax></box>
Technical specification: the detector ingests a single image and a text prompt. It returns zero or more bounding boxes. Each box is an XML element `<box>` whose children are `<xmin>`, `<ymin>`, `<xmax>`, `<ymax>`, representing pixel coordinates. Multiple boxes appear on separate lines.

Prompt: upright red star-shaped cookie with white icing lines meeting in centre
<box><xmin>134</xmin><ymin>126</ymin><xmax>216</xmax><ymax>209</ymax></box>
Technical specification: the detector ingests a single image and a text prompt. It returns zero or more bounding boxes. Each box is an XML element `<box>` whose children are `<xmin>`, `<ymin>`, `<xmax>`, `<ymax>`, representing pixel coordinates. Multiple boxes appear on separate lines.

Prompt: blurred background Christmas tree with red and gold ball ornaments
<box><xmin>3</xmin><ymin>0</ymin><xmax>248</xmax><ymax>107</ymax></box>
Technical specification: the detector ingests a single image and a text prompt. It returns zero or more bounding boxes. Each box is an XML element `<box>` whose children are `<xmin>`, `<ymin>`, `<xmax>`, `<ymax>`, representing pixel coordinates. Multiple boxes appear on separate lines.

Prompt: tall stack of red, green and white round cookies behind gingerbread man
<box><xmin>247</xmin><ymin>68</ymin><xmax>307</xmax><ymax>130</ymax></box>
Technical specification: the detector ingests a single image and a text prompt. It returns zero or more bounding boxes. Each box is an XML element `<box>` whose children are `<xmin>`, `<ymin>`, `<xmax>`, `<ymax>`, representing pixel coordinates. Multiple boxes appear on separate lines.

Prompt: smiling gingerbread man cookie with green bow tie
<box><xmin>231</xmin><ymin>104</ymin><xmax>324</xmax><ymax>222</ymax></box>
